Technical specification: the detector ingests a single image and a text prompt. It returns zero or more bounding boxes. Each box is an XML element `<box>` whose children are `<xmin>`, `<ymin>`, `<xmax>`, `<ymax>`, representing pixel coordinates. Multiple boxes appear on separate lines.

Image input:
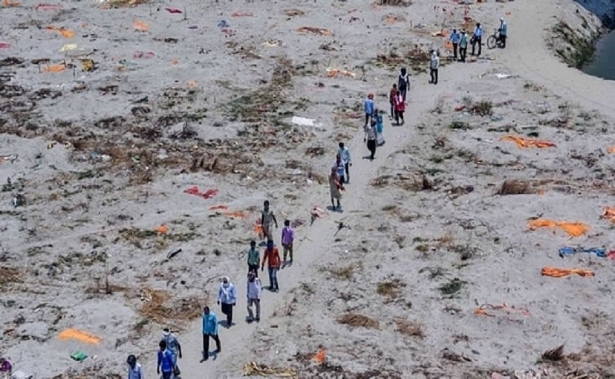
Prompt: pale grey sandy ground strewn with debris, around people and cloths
<box><xmin>0</xmin><ymin>0</ymin><xmax>615</xmax><ymax>379</ymax></box>
